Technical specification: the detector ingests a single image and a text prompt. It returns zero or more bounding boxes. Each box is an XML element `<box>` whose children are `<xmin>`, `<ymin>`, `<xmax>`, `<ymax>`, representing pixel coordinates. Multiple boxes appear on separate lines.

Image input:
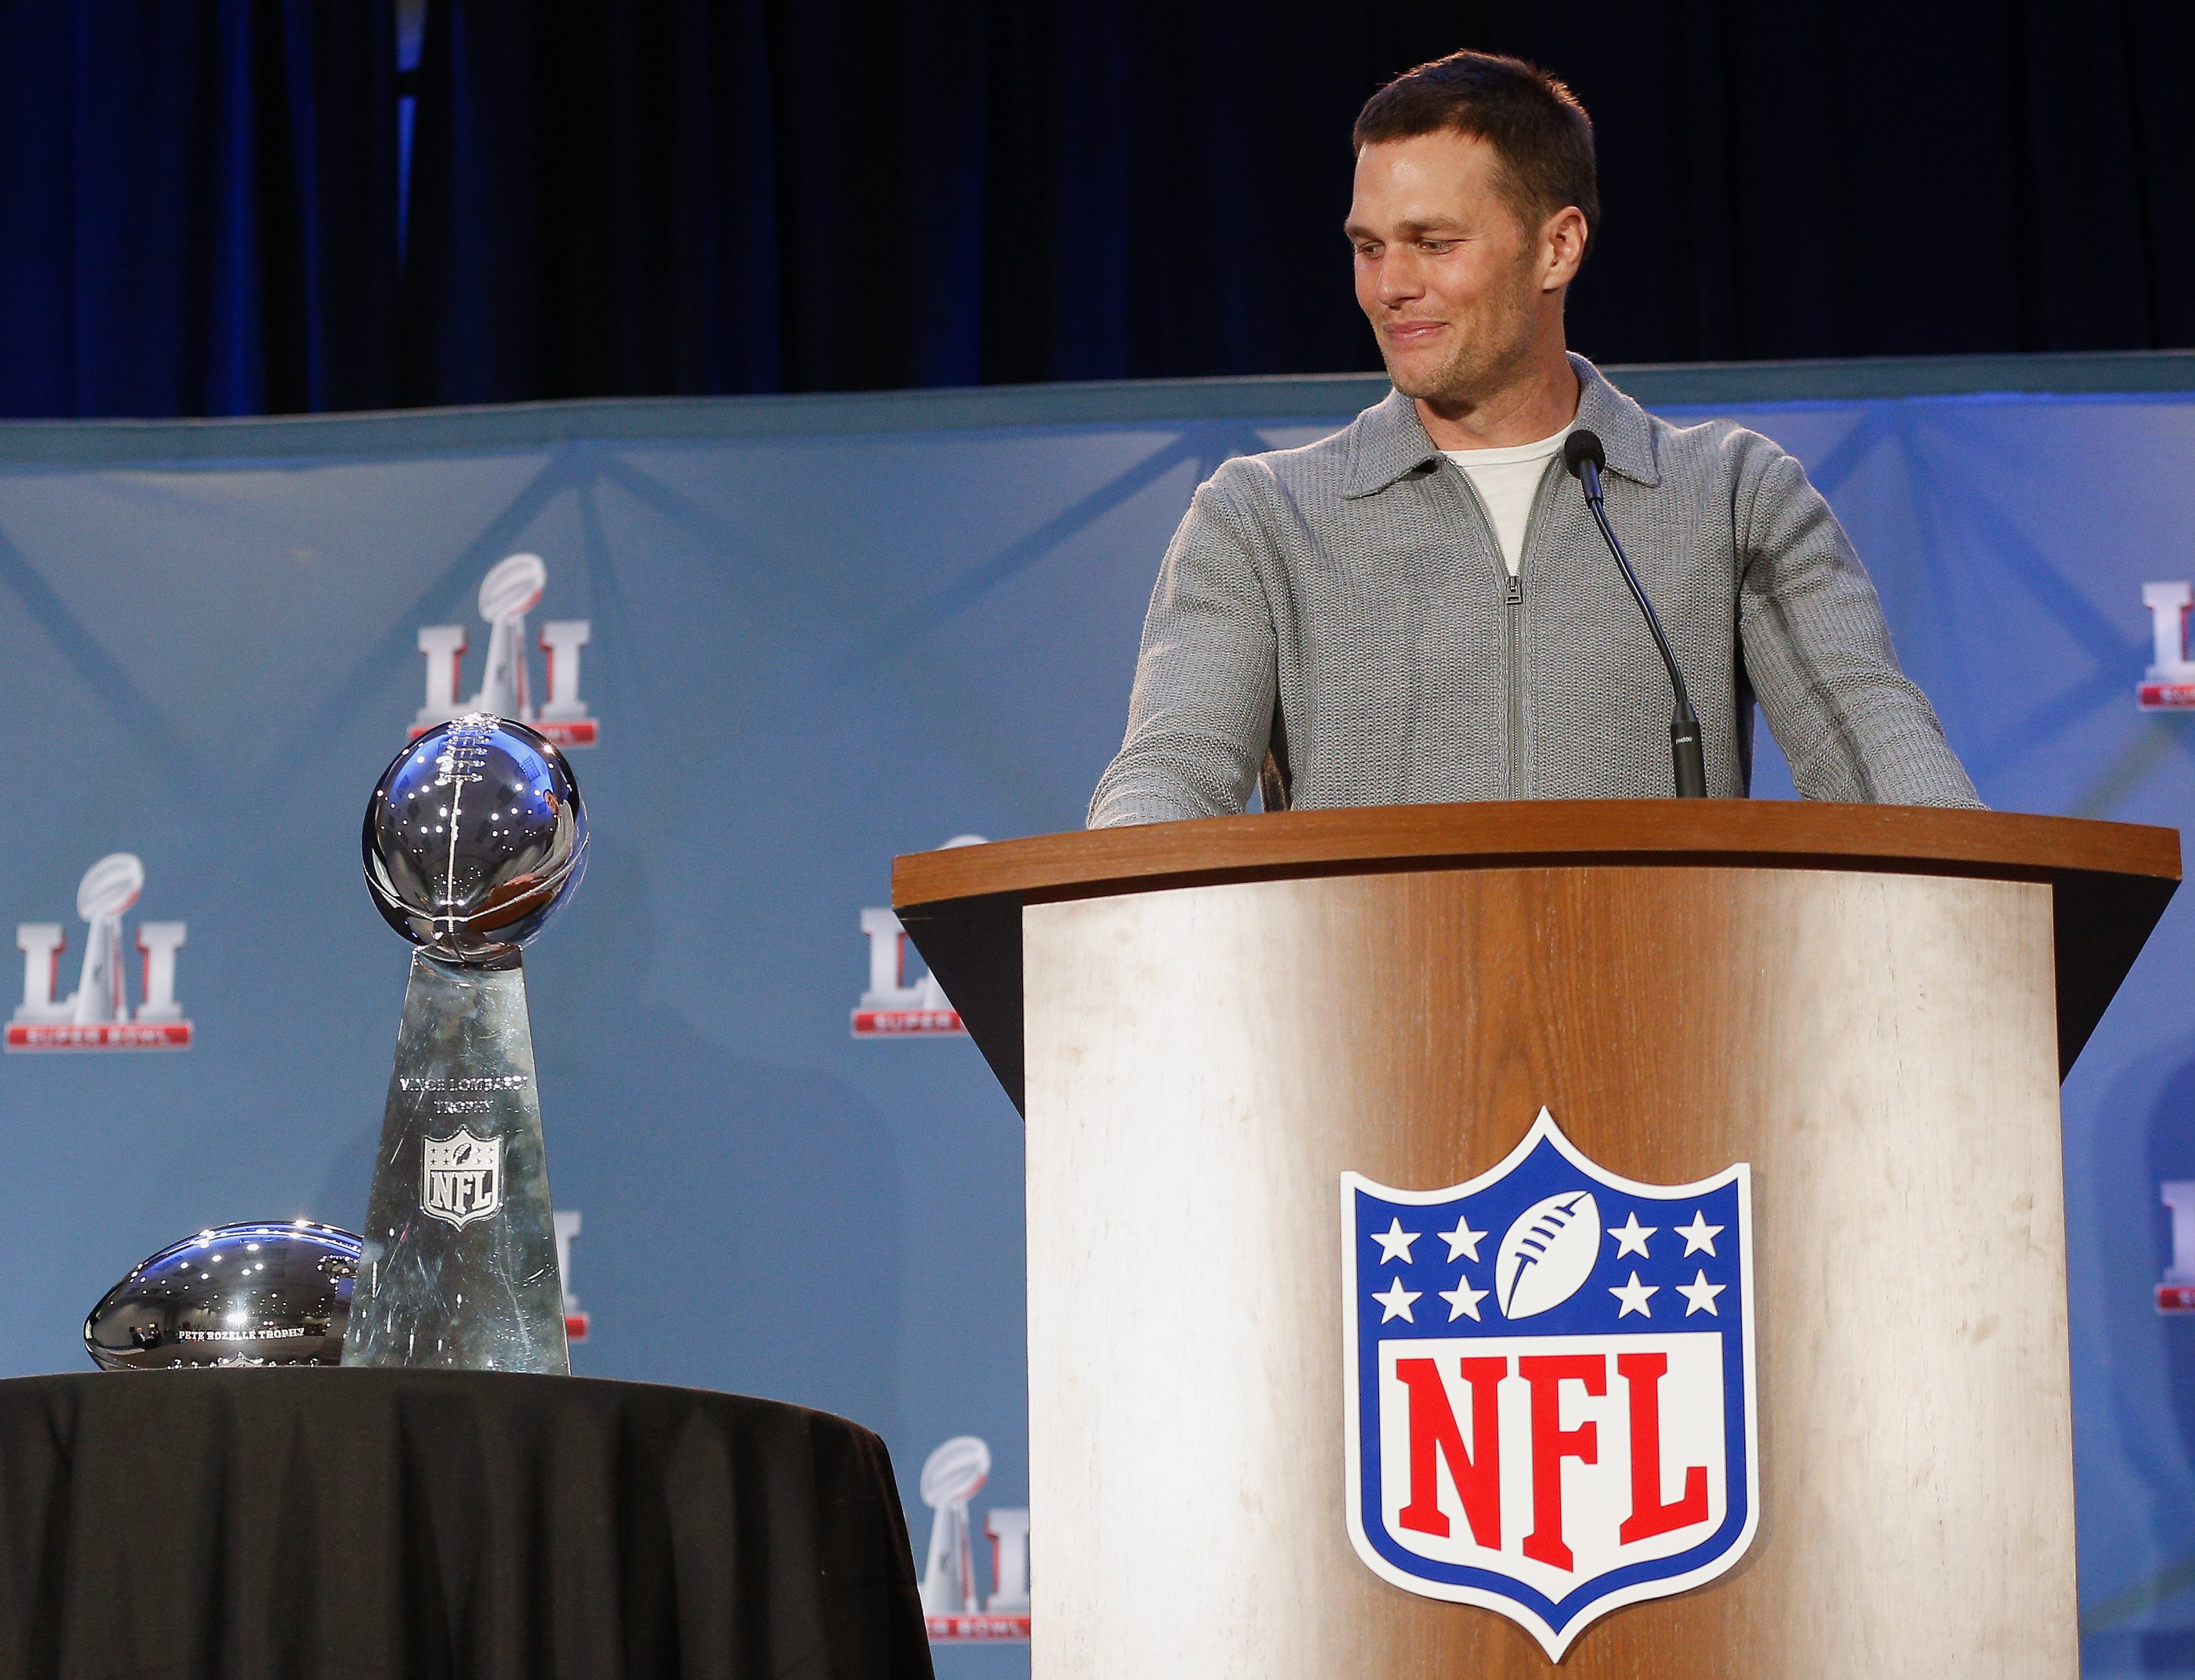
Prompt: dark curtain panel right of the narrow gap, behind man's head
<box><xmin>406</xmin><ymin>0</ymin><xmax>2195</xmax><ymax>402</ymax></box>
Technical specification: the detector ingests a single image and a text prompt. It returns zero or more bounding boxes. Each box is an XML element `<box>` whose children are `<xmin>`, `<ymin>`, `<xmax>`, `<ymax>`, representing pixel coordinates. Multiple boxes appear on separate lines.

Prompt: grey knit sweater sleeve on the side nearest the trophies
<box><xmin>1088</xmin><ymin>468</ymin><xmax>1278</xmax><ymax>828</ymax></box>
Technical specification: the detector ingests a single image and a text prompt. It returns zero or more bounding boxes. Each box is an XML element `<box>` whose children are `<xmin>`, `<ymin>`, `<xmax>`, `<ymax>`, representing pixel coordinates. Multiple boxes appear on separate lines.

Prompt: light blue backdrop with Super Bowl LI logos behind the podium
<box><xmin>0</xmin><ymin>358</ymin><xmax>2195</xmax><ymax>1676</ymax></box>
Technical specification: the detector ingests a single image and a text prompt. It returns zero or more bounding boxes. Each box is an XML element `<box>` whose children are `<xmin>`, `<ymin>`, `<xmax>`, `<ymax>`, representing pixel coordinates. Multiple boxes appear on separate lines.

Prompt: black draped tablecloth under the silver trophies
<box><xmin>0</xmin><ymin>1370</ymin><xmax>930</xmax><ymax>1680</ymax></box>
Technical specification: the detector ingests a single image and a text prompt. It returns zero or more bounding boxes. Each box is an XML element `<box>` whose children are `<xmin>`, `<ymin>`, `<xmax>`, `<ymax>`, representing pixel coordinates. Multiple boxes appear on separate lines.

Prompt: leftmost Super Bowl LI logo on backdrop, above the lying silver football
<box><xmin>7</xmin><ymin>852</ymin><xmax>191</xmax><ymax>1050</ymax></box>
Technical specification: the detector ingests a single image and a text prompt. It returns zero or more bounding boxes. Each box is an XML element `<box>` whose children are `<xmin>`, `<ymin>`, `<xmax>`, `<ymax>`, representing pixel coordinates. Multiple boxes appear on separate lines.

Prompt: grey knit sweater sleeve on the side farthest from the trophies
<box><xmin>1736</xmin><ymin>433</ymin><xmax>1982</xmax><ymax>808</ymax></box>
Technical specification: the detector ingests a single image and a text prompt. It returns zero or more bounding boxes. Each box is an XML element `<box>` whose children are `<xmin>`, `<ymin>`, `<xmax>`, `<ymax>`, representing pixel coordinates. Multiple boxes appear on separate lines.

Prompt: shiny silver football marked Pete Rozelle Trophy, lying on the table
<box><xmin>83</xmin><ymin>1219</ymin><xmax>360</xmax><ymax>1370</ymax></box>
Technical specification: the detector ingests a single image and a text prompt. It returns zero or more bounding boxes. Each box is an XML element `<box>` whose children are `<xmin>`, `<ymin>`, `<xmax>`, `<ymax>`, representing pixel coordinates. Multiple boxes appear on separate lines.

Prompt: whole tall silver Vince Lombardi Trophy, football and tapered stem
<box><xmin>343</xmin><ymin>712</ymin><xmax>586</xmax><ymax>1375</ymax></box>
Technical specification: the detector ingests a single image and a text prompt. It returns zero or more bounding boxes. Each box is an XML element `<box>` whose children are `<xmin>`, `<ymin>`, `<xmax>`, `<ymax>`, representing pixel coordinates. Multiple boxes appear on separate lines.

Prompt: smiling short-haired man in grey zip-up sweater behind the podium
<box><xmin>1088</xmin><ymin>53</ymin><xmax>1980</xmax><ymax>828</ymax></box>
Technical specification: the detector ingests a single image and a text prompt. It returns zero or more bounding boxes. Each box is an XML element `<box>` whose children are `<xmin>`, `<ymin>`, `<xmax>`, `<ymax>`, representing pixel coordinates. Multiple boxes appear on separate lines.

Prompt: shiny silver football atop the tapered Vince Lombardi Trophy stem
<box><xmin>362</xmin><ymin>712</ymin><xmax>586</xmax><ymax>968</ymax></box>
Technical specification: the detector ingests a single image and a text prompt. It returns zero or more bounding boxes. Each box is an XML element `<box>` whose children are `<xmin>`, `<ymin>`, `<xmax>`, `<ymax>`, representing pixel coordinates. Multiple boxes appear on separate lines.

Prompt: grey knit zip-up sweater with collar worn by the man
<box><xmin>1088</xmin><ymin>356</ymin><xmax>1980</xmax><ymax>828</ymax></box>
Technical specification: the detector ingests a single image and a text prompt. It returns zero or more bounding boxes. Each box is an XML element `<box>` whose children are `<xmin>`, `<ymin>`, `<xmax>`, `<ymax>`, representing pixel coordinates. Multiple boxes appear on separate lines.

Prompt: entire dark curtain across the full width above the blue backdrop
<box><xmin>0</xmin><ymin>0</ymin><xmax>2195</xmax><ymax>415</ymax></box>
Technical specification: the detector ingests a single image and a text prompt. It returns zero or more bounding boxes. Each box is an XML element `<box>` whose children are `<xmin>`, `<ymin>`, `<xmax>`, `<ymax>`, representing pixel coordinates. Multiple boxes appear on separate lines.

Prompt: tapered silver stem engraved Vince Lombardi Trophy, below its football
<box><xmin>343</xmin><ymin>953</ymin><xmax>571</xmax><ymax>1375</ymax></box>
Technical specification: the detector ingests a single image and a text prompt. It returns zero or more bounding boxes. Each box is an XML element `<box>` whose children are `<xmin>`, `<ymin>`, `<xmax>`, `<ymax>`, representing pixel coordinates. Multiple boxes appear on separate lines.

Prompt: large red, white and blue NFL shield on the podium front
<box><xmin>1341</xmin><ymin>1109</ymin><xmax>1760</xmax><ymax>1663</ymax></box>
